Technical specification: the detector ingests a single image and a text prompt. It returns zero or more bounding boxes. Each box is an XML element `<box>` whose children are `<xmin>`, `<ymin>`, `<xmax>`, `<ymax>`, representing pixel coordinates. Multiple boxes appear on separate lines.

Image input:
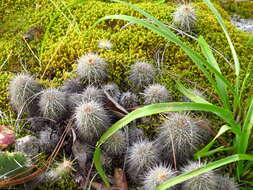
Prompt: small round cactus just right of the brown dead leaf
<box><xmin>119</xmin><ymin>91</ymin><xmax>138</xmax><ymax>108</ymax></box>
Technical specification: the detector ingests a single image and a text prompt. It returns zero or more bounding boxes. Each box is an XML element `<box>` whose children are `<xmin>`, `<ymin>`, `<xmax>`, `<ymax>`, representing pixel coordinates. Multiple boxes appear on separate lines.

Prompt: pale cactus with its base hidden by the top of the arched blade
<box><xmin>143</xmin><ymin>84</ymin><xmax>171</xmax><ymax>104</ymax></box>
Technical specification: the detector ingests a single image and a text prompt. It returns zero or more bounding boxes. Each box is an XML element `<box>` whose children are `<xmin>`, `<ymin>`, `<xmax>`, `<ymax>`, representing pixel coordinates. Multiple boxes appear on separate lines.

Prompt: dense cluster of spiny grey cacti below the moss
<box><xmin>7</xmin><ymin>50</ymin><xmax>236</xmax><ymax>190</ymax></box>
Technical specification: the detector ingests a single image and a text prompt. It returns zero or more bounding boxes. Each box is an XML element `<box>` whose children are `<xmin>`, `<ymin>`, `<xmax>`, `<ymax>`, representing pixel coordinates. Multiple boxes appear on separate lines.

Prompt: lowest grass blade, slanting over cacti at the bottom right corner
<box><xmin>156</xmin><ymin>154</ymin><xmax>253</xmax><ymax>190</ymax></box>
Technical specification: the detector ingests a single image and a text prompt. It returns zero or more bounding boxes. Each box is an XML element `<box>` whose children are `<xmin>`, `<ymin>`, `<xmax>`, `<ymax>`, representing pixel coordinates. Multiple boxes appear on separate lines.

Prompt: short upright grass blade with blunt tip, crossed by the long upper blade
<box><xmin>198</xmin><ymin>36</ymin><xmax>230</xmax><ymax>109</ymax></box>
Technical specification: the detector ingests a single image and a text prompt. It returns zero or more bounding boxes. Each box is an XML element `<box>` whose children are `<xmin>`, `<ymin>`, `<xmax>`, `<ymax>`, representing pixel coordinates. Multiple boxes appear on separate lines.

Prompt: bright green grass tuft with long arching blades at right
<box><xmin>94</xmin><ymin>0</ymin><xmax>253</xmax><ymax>190</ymax></box>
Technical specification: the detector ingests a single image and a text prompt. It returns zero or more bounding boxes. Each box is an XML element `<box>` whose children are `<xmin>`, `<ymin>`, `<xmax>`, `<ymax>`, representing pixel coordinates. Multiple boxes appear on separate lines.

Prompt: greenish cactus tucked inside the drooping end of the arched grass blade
<box><xmin>102</xmin><ymin>131</ymin><xmax>127</xmax><ymax>156</ymax></box>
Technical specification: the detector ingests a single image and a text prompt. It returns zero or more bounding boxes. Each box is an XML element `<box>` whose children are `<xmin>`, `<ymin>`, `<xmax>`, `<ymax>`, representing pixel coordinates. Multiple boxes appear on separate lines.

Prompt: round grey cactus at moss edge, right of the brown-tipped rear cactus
<box><xmin>128</xmin><ymin>61</ymin><xmax>156</xmax><ymax>89</ymax></box>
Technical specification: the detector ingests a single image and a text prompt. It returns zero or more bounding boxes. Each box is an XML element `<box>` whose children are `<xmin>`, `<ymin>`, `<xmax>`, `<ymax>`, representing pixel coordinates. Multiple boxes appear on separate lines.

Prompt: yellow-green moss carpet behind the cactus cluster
<box><xmin>0</xmin><ymin>0</ymin><xmax>253</xmax><ymax>111</ymax></box>
